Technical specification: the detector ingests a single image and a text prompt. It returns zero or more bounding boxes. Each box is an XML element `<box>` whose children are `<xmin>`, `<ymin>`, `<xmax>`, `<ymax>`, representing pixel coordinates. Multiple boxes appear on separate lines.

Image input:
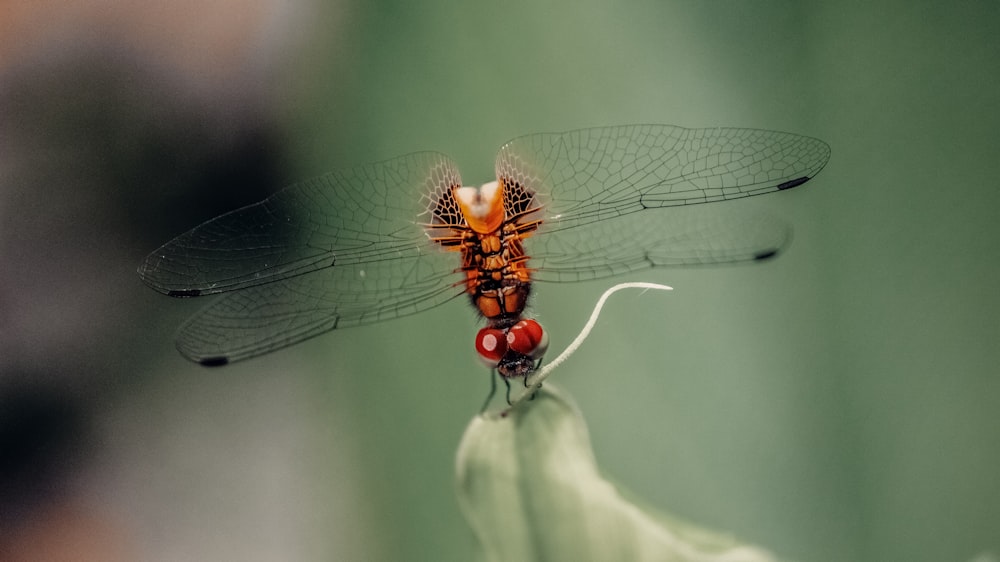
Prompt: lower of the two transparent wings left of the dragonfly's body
<box><xmin>177</xmin><ymin>249</ymin><xmax>462</xmax><ymax>365</ymax></box>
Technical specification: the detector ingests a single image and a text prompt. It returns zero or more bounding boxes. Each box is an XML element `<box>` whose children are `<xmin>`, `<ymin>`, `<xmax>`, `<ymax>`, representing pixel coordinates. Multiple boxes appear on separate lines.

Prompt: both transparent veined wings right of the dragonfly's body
<box><xmin>496</xmin><ymin>125</ymin><xmax>830</xmax><ymax>281</ymax></box>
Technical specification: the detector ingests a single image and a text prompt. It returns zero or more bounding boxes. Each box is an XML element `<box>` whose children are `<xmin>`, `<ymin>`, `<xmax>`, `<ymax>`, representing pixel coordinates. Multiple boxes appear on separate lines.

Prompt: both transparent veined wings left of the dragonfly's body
<box><xmin>139</xmin><ymin>153</ymin><xmax>462</xmax><ymax>365</ymax></box>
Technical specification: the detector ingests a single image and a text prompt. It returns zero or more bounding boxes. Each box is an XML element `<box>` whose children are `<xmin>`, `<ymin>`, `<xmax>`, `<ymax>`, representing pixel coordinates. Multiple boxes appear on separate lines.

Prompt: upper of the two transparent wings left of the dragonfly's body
<box><xmin>139</xmin><ymin>152</ymin><xmax>461</xmax><ymax>297</ymax></box>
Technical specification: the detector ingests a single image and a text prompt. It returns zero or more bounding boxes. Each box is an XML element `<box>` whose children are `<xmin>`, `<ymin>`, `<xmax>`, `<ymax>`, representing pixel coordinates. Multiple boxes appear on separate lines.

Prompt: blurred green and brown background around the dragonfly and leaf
<box><xmin>0</xmin><ymin>0</ymin><xmax>1000</xmax><ymax>561</ymax></box>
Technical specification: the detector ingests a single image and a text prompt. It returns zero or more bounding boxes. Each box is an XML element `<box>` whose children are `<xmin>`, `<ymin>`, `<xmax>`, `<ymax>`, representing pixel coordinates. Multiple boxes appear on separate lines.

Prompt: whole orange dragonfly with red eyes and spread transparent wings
<box><xmin>138</xmin><ymin>125</ymin><xmax>830</xmax><ymax>376</ymax></box>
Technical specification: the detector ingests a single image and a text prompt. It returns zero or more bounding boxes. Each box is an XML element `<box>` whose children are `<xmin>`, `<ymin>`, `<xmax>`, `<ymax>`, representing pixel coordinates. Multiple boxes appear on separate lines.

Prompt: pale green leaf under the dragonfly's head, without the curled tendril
<box><xmin>456</xmin><ymin>383</ymin><xmax>774</xmax><ymax>562</ymax></box>
